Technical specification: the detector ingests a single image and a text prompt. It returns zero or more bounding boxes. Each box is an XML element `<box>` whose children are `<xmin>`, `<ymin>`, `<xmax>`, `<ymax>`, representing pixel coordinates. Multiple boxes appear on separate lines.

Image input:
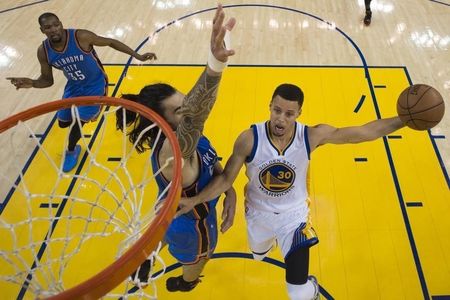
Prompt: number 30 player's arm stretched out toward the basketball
<box><xmin>308</xmin><ymin>117</ymin><xmax>405</xmax><ymax>151</ymax></box>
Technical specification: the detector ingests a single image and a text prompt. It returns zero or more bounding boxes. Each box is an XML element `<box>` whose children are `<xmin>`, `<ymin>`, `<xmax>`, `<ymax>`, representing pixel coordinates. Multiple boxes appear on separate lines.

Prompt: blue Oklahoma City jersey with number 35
<box><xmin>43</xmin><ymin>29</ymin><xmax>108</xmax><ymax>98</ymax></box>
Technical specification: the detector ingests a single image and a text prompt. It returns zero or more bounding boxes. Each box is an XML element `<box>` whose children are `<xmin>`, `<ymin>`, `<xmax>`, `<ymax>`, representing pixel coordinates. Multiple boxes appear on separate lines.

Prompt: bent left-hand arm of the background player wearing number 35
<box><xmin>6</xmin><ymin>45</ymin><xmax>53</xmax><ymax>90</ymax></box>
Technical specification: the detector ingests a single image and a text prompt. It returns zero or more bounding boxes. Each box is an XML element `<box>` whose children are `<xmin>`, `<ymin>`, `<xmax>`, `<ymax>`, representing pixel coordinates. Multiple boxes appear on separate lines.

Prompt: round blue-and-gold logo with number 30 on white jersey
<box><xmin>259</xmin><ymin>163</ymin><xmax>295</xmax><ymax>193</ymax></box>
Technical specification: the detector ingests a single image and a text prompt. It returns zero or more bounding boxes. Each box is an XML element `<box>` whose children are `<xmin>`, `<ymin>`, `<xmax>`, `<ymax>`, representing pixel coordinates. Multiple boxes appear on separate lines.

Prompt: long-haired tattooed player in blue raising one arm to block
<box><xmin>116</xmin><ymin>5</ymin><xmax>236</xmax><ymax>292</ymax></box>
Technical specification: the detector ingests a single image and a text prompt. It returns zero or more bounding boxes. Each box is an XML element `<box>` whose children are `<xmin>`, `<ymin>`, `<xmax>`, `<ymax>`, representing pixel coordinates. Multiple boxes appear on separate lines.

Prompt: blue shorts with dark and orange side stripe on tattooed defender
<box><xmin>164</xmin><ymin>208</ymin><xmax>217</xmax><ymax>264</ymax></box>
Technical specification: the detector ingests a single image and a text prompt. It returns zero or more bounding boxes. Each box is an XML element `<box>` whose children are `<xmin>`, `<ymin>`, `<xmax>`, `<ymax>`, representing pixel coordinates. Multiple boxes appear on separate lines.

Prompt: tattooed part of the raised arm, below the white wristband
<box><xmin>176</xmin><ymin>69</ymin><xmax>221</xmax><ymax>158</ymax></box>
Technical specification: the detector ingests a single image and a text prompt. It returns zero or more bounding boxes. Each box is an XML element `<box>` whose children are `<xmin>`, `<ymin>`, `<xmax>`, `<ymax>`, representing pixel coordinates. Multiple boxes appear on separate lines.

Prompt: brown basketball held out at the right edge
<box><xmin>397</xmin><ymin>84</ymin><xmax>445</xmax><ymax>130</ymax></box>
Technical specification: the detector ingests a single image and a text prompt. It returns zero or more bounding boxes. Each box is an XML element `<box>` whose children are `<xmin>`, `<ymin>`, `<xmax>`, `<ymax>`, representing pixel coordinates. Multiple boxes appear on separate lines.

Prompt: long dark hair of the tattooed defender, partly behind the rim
<box><xmin>116</xmin><ymin>83</ymin><xmax>177</xmax><ymax>153</ymax></box>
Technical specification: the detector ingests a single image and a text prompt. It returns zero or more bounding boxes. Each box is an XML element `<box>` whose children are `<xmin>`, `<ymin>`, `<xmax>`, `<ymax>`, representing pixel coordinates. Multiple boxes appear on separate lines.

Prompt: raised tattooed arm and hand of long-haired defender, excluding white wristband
<box><xmin>176</xmin><ymin>5</ymin><xmax>236</xmax><ymax>159</ymax></box>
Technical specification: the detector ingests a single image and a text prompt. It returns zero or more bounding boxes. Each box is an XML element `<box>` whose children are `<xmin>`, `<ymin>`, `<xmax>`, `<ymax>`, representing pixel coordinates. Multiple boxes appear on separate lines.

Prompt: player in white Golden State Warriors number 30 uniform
<box><xmin>177</xmin><ymin>84</ymin><xmax>404</xmax><ymax>300</ymax></box>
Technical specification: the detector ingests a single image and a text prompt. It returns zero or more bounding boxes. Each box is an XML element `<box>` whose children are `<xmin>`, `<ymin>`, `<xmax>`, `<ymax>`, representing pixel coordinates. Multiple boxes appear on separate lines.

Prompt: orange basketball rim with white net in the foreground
<box><xmin>0</xmin><ymin>97</ymin><xmax>182</xmax><ymax>299</ymax></box>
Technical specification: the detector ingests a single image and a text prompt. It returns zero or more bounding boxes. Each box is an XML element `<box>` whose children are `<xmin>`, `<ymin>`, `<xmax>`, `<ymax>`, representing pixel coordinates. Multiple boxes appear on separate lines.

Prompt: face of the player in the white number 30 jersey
<box><xmin>270</xmin><ymin>95</ymin><xmax>301</xmax><ymax>137</ymax></box>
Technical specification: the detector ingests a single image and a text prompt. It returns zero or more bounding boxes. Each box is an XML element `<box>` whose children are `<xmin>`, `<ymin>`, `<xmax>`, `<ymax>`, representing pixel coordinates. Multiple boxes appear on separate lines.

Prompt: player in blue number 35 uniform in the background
<box><xmin>7</xmin><ymin>13</ymin><xmax>156</xmax><ymax>172</ymax></box>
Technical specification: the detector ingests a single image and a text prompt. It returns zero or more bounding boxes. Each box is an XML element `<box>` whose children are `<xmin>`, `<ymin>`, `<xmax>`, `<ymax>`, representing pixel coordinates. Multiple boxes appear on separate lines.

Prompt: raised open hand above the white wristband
<box><xmin>211</xmin><ymin>4</ymin><xmax>236</xmax><ymax>62</ymax></box>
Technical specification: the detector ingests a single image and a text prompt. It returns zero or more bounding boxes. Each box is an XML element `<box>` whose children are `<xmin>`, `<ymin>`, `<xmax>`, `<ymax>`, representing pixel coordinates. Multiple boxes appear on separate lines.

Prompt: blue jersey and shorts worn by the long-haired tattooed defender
<box><xmin>152</xmin><ymin>136</ymin><xmax>219</xmax><ymax>264</ymax></box>
